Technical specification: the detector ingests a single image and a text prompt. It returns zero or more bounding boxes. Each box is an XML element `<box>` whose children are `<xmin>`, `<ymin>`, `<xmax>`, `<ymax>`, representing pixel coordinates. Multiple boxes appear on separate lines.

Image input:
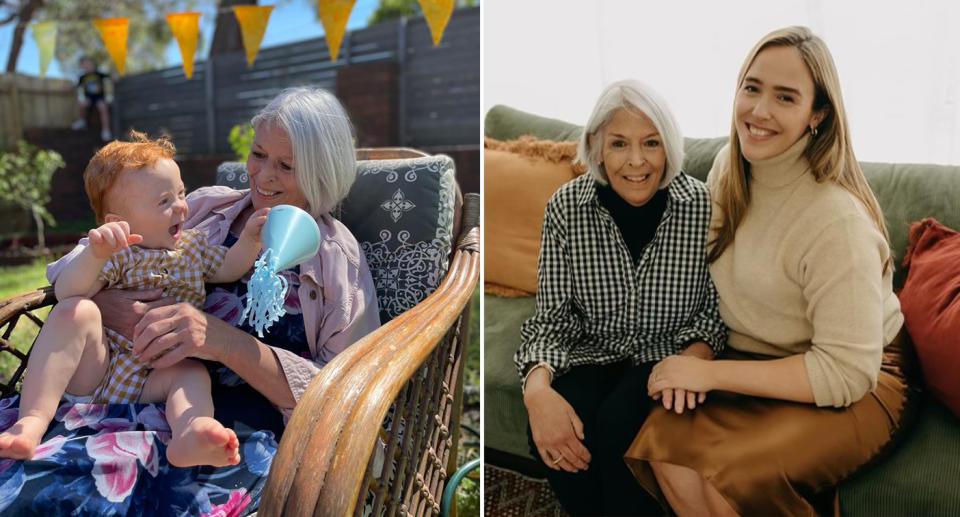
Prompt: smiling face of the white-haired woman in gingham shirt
<box><xmin>599</xmin><ymin>108</ymin><xmax>667</xmax><ymax>206</ymax></box>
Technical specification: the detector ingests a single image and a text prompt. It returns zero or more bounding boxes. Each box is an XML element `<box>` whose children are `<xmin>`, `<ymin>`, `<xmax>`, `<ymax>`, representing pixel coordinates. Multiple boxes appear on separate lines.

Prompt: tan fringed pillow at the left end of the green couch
<box><xmin>483</xmin><ymin>136</ymin><xmax>585</xmax><ymax>294</ymax></box>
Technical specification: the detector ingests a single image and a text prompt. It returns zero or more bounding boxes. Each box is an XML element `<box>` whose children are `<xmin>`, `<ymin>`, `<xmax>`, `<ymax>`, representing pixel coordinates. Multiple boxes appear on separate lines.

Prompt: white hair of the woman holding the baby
<box><xmin>250</xmin><ymin>88</ymin><xmax>357</xmax><ymax>217</ymax></box>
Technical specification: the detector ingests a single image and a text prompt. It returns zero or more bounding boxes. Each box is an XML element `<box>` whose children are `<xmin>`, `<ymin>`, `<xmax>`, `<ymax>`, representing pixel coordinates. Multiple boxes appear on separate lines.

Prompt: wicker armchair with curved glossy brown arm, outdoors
<box><xmin>0</xmin><ymin>149</ymin><xmax>480</xmax><ymax>516</ymax></box>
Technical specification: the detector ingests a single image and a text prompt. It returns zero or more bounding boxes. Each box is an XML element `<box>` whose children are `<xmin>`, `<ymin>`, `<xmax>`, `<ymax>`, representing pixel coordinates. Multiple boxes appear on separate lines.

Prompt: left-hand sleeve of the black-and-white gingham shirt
<box><xmin>514</xmin><ymin>196</ymin><xmax>583</xmax><ymax>377</ymax></box>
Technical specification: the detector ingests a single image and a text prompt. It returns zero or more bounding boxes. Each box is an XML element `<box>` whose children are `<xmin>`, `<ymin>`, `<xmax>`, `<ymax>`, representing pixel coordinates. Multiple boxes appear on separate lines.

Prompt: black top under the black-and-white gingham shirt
<box><xmin>597</xmin><ymin>183</ymin><xmax>668</xmax><ymax>265</ymax></box>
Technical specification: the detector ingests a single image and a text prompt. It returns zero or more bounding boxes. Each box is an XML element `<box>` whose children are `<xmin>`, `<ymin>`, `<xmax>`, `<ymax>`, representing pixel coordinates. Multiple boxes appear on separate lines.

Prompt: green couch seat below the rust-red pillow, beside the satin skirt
<box><xmin>840</xmin><ymin>397</ymin><xmax>960</xmax><ymax>517</ymax></box>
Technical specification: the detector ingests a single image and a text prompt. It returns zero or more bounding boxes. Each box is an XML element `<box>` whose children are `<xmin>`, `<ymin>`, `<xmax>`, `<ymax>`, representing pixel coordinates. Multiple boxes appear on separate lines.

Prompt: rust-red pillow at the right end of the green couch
<box><xmin>900</xmin><ymin>218</ymin><xmax>960</xmax><ymax>417</ymax></box>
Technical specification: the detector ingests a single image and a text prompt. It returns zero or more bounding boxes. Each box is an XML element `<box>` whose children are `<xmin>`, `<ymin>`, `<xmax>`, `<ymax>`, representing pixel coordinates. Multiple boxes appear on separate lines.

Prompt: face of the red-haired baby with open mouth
<box><xmin>105</xmin><ymin>158</ymin><xmax>187</xmax><ymax>249</ymax></box>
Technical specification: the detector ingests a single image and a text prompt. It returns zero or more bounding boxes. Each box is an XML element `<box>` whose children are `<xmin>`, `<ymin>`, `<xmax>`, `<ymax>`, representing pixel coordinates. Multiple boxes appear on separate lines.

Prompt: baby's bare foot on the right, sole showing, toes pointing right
<box><xmin>167</xmin><ymin>417</ymin><xmax>240</xmax><ymax>467</ymax></box>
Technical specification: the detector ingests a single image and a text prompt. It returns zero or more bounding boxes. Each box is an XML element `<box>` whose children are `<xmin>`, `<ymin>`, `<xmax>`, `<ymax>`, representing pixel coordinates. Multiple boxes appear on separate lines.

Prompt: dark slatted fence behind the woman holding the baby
<box><xmin>114</xmin><ymin>7</ymin><xmax>480</xmax><ymax>156</ymax></box>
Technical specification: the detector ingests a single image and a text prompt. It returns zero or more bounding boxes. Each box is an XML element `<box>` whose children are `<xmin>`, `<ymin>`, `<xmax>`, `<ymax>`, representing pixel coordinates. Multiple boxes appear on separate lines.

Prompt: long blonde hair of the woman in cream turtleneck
<box><xmin>707</xmin><ymin>27</ymin><xmax>893</xmax><ymax>272</ymax></box>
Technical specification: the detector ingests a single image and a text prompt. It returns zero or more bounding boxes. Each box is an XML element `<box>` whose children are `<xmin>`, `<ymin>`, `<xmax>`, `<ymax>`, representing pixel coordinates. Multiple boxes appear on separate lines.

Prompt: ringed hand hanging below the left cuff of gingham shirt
<box><xmin>523</xmin><ymin>371</ymin><xmax>590</xmax><ymax>472</ymax></box>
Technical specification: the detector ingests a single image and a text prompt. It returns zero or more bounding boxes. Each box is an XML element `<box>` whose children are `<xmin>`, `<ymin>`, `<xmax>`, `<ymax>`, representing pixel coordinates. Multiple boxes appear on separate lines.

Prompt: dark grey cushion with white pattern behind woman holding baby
<box><xmin>217</xmin><ymin>154</ymin><xmax>456</xmax><ymax>323</ymax></box>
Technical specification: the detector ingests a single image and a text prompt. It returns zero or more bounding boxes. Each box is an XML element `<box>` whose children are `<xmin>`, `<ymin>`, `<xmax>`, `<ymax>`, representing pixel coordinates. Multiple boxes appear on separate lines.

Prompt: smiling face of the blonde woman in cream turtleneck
<box><xmin>734</xmin><ymin>46</ymin><xmax>824</xmax><ymax>160</ymax></box>
